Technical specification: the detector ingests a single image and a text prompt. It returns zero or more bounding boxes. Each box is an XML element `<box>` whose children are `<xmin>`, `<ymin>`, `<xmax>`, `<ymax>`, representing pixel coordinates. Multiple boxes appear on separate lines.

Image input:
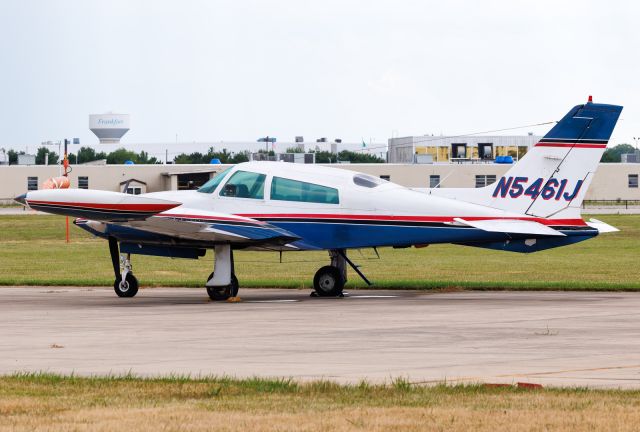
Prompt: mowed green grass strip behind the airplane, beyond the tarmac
<box><xmin>0</xmin><ymin>215</ymin><xmax>640</xmax><ymax>290</ymax></box>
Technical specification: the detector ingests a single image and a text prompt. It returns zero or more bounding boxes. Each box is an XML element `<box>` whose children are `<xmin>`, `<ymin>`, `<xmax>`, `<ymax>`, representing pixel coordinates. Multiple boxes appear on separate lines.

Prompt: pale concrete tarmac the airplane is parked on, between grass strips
<box><xmin>0</xmin><ymin>287</ymin><xmax>640</xmax><ymax>388</ymax></box>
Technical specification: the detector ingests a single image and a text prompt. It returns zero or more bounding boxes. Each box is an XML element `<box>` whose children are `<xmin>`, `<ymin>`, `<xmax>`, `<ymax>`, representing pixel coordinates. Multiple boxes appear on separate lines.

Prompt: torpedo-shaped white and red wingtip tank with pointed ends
<box><xmin>16</xmin><ymin>189</ymin><xmax>181</xmax><ymax>221</ymax></box>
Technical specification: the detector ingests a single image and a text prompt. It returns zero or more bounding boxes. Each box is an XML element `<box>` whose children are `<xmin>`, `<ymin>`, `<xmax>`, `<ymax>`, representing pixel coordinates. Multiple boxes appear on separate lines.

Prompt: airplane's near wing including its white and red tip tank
<box><xmin>17</xmin><ymin>189</ymin><xmax>300</xmax><ymax>245</ymax></box>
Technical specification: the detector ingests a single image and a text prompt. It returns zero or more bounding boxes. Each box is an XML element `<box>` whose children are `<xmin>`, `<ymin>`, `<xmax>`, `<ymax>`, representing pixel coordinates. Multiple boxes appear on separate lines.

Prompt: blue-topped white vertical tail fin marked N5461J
<box><xmin>433</xmin><ymin>99</ymin><xmax>622</xmax><ymax>218</ymax></box>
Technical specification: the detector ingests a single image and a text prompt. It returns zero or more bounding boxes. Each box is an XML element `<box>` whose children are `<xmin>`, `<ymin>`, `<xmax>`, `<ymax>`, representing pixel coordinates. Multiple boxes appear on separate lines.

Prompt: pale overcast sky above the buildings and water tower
<box><xmin>0</xmin><ymin>0</ymin><xmax>640</xmax><ymax>154</ymax></box>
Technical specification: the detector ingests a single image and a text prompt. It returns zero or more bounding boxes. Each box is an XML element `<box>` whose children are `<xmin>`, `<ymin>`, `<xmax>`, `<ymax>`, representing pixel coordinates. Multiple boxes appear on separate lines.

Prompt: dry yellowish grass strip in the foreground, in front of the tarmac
<box><xmin>0</xmin><ymin>374</ymin><xmax>640</xmax><ymax>432</ymax></box>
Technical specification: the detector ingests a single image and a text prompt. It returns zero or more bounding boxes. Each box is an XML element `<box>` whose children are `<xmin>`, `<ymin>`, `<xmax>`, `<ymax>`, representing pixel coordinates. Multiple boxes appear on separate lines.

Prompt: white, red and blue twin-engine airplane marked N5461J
<box><xmin>16</xmin><ymin>100</ymin><xmax>622</xmax><ymax>300</ymax></box>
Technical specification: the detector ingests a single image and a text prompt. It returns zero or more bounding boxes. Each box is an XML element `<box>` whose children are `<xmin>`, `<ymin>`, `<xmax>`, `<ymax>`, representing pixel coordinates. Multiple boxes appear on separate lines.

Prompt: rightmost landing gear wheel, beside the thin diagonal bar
<box><xmin>311</xmin><ymin>249</ymin><xmax>371</xmax><ymax>297</ymax></box>
